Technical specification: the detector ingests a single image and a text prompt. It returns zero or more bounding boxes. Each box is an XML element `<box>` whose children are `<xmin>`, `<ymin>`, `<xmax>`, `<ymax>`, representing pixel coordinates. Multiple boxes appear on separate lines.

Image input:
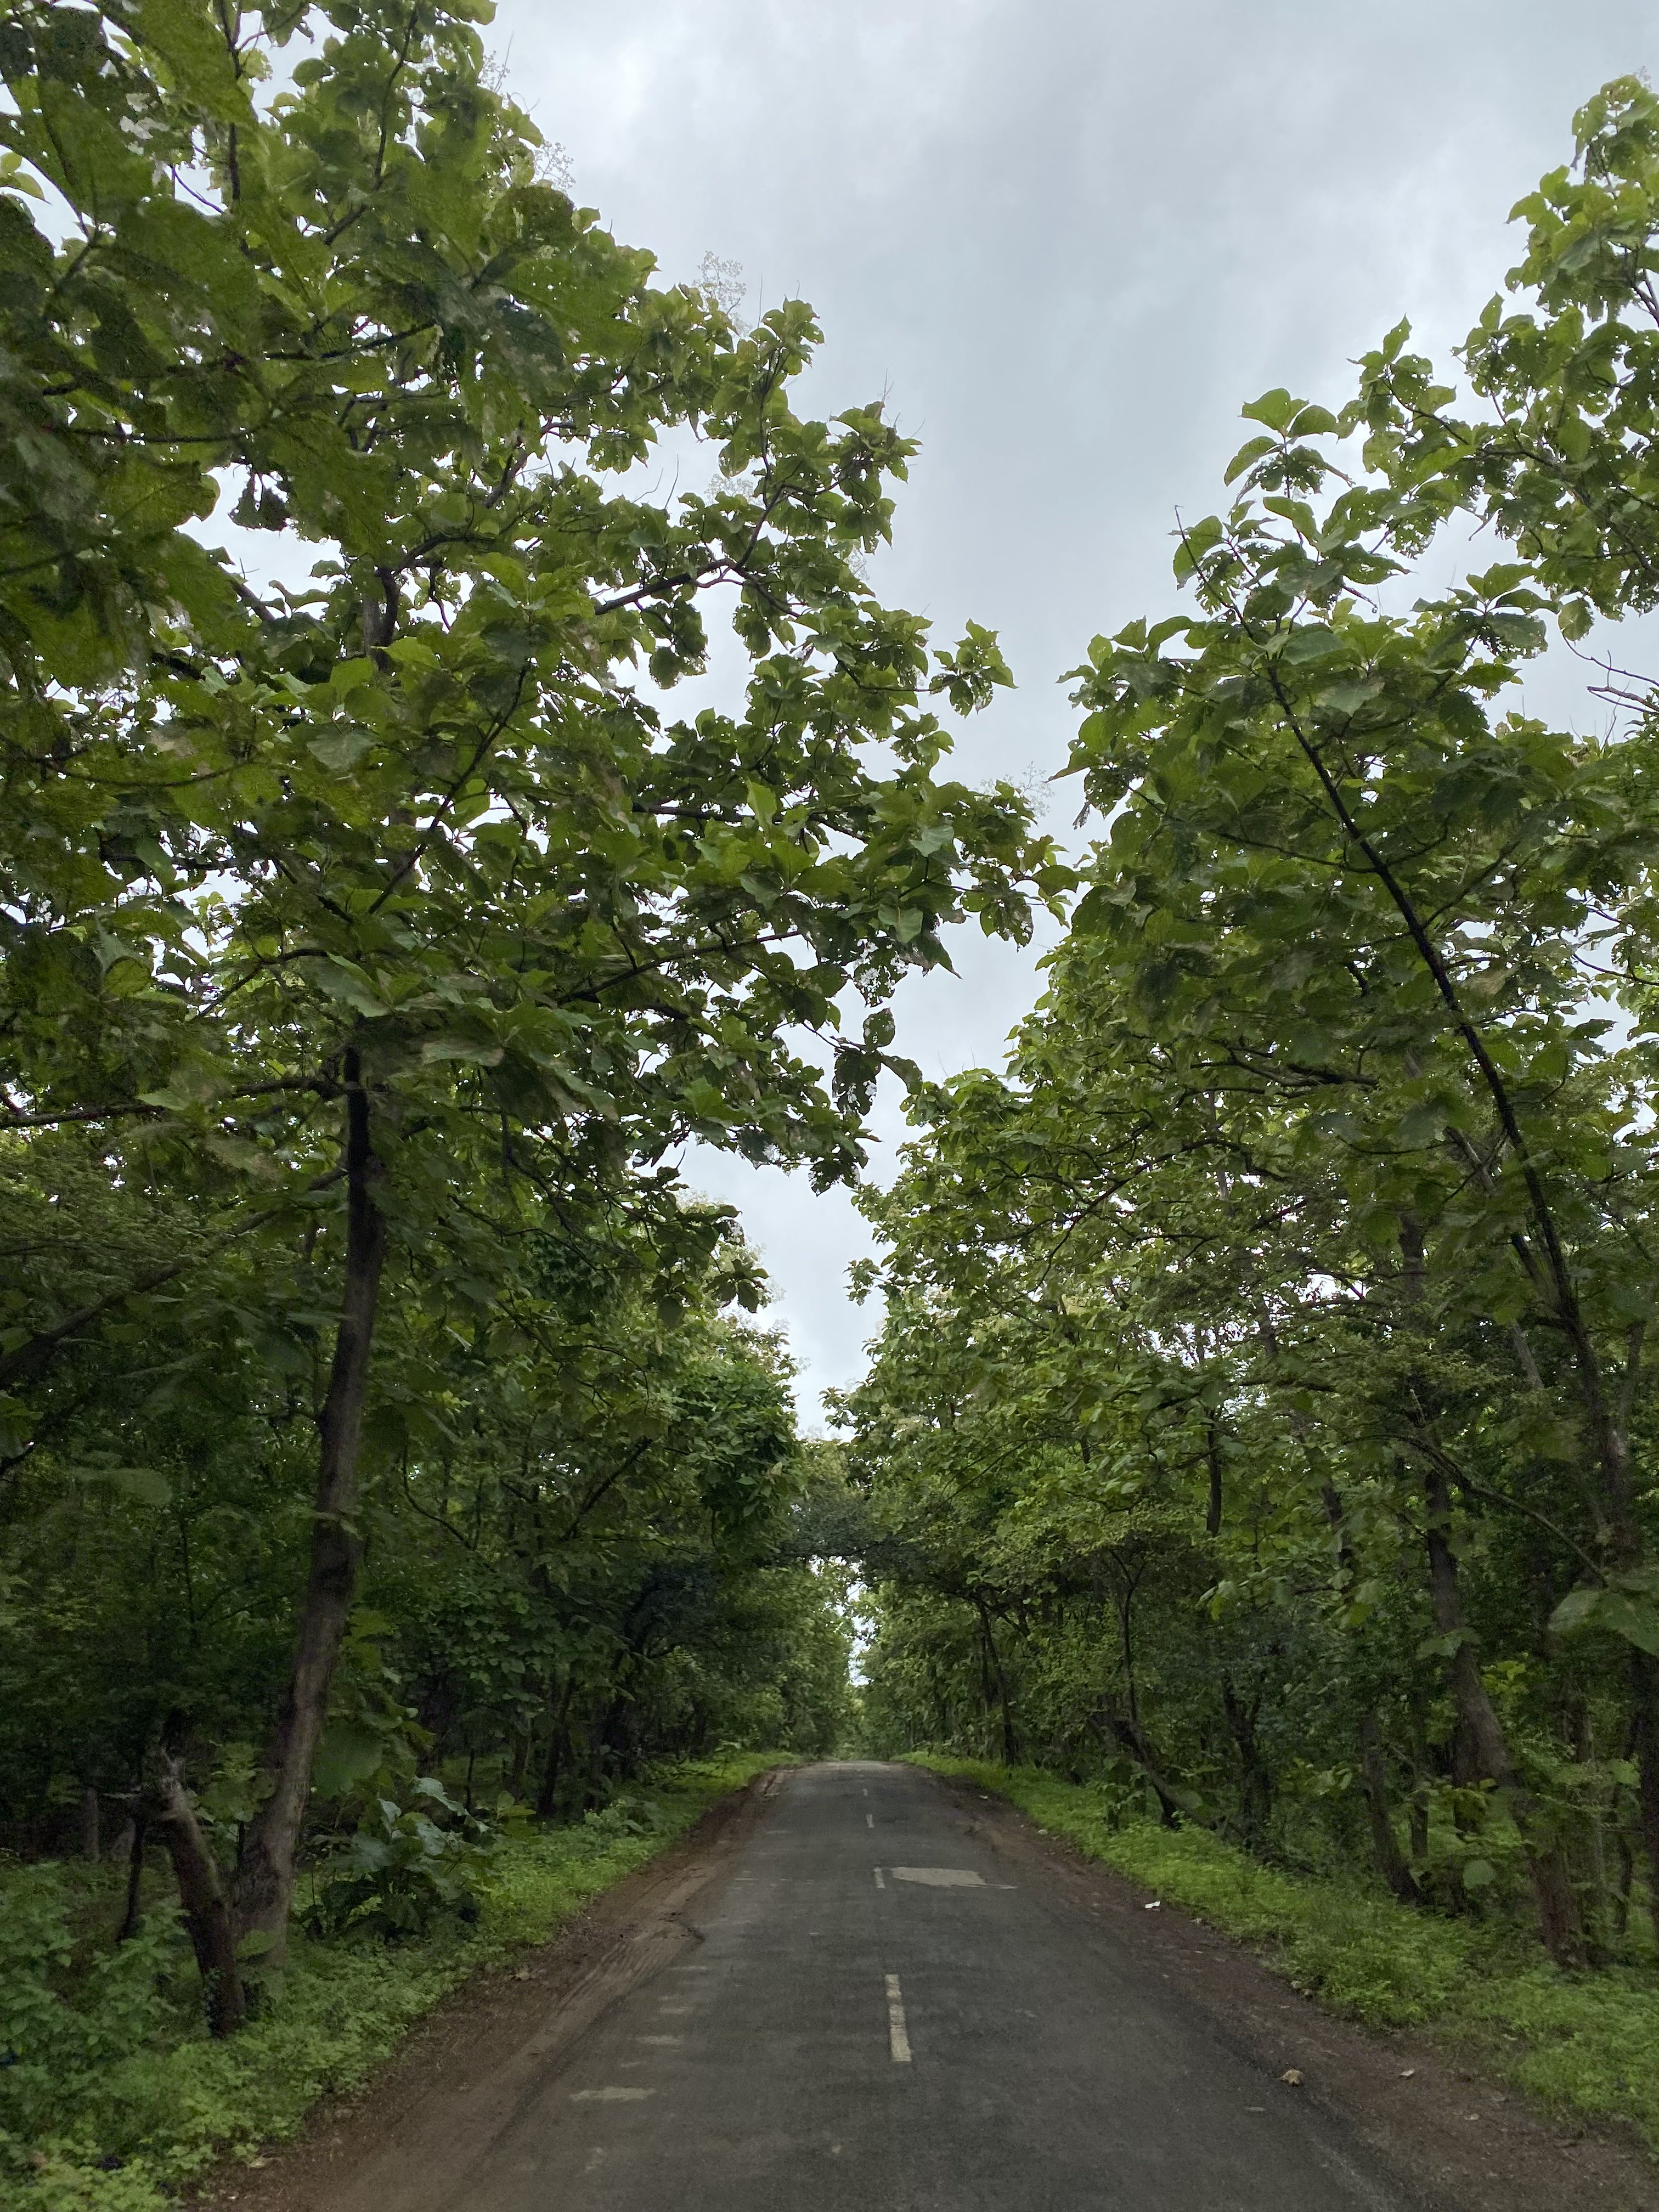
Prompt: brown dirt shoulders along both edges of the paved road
<box><xmin>193</xmin><ymin>1774</ymin><xmax>1659</xmax><ymax>2212</ymax></box>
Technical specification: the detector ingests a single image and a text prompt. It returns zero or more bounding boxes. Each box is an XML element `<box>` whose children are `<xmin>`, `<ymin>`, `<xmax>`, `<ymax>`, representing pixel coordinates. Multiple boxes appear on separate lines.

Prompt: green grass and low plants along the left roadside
<box><xmin>0</xmin><ymin>1752</ymin><xmax>787</xmax><ymax>2212</ymax></box>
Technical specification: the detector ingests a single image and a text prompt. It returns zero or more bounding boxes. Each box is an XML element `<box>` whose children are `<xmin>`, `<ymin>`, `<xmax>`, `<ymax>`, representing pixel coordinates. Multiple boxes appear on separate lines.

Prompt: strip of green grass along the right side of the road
<box><xmin>911</xmin><ymin>1752</ymin><xmax>1659</xmax><ymax>2150</ymax></box>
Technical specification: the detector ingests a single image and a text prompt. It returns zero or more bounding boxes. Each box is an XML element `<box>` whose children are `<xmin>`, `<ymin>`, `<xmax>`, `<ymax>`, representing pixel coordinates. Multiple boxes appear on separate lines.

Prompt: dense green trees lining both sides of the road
<box><xmin>13</xmin><ymin>0</ymin><xmax>1659</xmax><ymax>2176</ymax></box>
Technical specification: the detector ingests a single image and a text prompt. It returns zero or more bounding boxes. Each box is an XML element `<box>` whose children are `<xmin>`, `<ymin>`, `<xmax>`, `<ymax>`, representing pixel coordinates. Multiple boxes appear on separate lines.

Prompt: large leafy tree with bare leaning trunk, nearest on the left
<box><xmin>0</xmin><ymin>0</ymin><xmax>1066</xmax><ymax>2017</ymax></box>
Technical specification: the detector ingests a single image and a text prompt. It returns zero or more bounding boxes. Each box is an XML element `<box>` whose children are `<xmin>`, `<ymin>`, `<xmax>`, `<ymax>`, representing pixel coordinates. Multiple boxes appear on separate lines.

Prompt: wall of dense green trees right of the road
<box><xmin>845</xmin><ymin>80</ymin><xmax>1659</xmax><ymax>1964</ymax></box>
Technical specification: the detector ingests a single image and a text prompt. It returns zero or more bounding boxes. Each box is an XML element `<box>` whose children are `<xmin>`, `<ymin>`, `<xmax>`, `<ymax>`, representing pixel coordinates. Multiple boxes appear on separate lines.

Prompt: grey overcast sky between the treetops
<box><xmin>493</xmin><ymin>0</ymin><xmax>1659</xmax><ymax>1423</ymax></box>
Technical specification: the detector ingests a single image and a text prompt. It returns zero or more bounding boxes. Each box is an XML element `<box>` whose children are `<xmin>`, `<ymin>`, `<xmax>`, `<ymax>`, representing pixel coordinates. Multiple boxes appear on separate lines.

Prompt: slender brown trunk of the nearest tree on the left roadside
<box><xmin>234</xmin><ymin>1051</ymin><xmax>387</xmax><ymax>1964</ymax></box>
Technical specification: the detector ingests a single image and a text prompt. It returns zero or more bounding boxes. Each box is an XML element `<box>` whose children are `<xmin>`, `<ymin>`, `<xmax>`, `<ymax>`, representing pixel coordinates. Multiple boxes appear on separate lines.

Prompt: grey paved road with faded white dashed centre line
<box><xmin>454</xmin><ymin>1763</ymin><xmax>1404</xmax><ymax>2212</ymax></box>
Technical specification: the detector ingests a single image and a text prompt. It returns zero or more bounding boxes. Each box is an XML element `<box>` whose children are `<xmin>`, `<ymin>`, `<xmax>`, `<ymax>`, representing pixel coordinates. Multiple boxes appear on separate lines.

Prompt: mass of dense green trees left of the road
<box><xmin>0</xmin><ymin>0</ymin><xmax>1066</xmax><ymax>2062</ymax></box>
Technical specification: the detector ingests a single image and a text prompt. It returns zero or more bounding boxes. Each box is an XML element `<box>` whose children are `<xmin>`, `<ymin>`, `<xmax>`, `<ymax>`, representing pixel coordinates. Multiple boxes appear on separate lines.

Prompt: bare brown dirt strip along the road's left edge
<box><xmin>193</xmin><ymin>1774</ymin><xmax>776</xmax><ymax>2212</ymax></box>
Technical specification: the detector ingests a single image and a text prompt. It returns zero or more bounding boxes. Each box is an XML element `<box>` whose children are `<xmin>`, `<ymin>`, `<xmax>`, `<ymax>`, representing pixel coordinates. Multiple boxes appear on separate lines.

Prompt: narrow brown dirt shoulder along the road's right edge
<box><xmin>938</xmin><ymin>1776</ymin><xmax>1659</xmax><ymax>2212</ymax></box>
